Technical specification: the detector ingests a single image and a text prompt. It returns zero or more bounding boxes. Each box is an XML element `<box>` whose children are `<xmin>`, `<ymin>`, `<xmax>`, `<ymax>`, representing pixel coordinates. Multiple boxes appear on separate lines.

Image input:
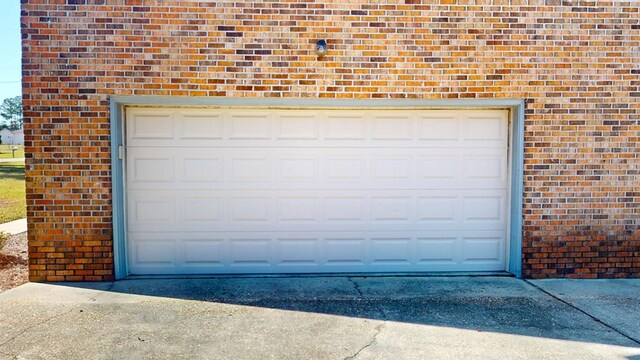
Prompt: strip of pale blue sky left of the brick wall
<box><xmin>0</xmin><ymin>0</ymin><xmax>22</xmax><ymax>102</ymax></box>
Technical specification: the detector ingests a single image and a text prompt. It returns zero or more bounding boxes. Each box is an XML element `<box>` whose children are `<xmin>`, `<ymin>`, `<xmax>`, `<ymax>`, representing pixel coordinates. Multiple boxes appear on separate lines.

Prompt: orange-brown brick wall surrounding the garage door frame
<box><xmin>22</xmin><ymin>0</ymin><xmax>640</xmax><ymax>281</ymax></box>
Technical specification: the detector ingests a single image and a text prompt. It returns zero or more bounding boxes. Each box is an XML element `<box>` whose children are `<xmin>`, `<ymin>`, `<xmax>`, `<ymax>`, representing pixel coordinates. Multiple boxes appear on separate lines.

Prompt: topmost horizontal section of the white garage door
<box><xmin>126</xmin><ymin>108</ymin><xmax>507</xmax><ymax>148</ymax></box>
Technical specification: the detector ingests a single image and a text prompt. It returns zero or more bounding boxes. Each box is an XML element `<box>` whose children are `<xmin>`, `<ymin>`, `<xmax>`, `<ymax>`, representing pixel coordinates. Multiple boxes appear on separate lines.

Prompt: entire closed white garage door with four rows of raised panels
<box><xmin>126</xmin><ymin>108</ymin><xmax>508</xmax><ymax>274</ymax></box>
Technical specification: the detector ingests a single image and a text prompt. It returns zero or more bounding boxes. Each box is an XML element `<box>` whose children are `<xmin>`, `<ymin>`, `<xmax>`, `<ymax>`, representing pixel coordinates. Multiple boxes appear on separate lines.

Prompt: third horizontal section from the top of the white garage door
<box><xmin>128</xmin><ymin>189</ymin><xmax>507</xmax><ymax>231</ymax></box>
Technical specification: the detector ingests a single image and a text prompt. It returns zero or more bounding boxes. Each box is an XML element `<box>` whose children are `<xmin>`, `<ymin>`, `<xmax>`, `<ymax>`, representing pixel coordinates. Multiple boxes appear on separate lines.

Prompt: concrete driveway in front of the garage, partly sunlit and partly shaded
<box><xmin>0</xmin><ymin>277</ymin><xmax>640</xmax><ymax>360</ymax></box>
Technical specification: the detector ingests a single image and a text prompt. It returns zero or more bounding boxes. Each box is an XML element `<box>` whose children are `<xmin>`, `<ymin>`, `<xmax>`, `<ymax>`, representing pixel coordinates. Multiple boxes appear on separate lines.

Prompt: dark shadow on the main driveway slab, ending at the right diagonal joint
<box><xmin>59</xmin><ymin>276</ymin><xmax>639</xmax><ymax>347</ymax></box>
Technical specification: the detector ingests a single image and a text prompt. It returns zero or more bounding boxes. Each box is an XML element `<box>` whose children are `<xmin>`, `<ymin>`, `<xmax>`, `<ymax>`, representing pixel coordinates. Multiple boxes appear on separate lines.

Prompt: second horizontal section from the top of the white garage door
<box><xmin>127</xmin><ymin>148</ymin><xmax>507</xmax><ymax>190</ymax></box>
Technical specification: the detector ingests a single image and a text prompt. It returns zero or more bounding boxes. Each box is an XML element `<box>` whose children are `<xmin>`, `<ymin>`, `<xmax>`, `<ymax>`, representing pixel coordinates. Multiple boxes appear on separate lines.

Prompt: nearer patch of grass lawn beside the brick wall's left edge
<box><xmin>0</xmin><ymin>162</ymin><xmax>27</xmax><ymax>223</ymax></box>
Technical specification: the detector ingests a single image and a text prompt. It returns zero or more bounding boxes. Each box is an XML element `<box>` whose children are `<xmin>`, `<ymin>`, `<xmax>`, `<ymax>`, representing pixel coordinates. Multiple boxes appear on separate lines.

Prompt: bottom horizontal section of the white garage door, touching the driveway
<box><xmin>130</xmin><ymin>231</ymin><xmax>505</xmax><ymax>273</ymax></box>
